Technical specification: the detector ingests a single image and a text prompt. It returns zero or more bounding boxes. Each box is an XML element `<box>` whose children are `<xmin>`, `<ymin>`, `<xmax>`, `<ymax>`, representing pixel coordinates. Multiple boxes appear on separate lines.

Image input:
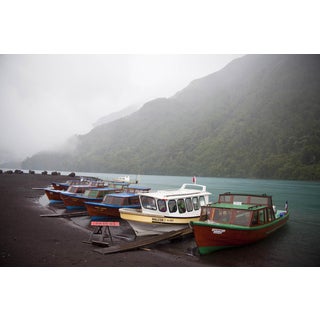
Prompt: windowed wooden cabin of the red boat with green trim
<box><xmin>200</xmin><ymin>203</ymin><xmax>275</xmax><ymax>227</ymax></box>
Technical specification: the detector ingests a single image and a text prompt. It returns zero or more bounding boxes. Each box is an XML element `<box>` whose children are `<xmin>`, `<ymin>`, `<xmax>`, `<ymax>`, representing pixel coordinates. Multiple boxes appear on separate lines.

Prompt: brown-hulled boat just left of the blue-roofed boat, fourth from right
<box><xmin>60</xmin><ymin>187</ymin><xmax>119</xmax><ymax>210</ymax></box>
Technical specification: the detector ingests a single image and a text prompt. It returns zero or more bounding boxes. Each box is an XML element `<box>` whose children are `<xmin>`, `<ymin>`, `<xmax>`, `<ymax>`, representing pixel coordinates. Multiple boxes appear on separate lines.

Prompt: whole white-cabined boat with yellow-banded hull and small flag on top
<box><xmin>119</xmin><ymin>183</ymin><xmax>211</xmax><ymax>236</ymax></box>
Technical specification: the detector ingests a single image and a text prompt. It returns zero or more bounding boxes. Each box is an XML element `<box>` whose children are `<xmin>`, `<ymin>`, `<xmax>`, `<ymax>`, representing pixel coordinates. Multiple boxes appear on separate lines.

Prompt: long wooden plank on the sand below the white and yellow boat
<box><xmin>94</xmin><ymin>227</ymin><xmax>192</xmax><ymax>254</ymax></box>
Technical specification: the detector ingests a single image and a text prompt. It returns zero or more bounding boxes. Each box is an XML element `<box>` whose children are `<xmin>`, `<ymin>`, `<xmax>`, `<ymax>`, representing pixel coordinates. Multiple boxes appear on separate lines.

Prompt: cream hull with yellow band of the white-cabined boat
<box><xmin>120</xmin><ymin>209</ymin><xmax>199</xmax><ymax>236</ymax></box>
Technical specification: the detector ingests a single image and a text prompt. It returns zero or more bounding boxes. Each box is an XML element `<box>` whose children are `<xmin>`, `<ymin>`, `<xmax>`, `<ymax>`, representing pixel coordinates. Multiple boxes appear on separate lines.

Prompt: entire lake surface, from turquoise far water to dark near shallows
<box><xmin>43</xmin><ymin>172</ymin><xmax>320</xmax><ymax>266</ymax></box>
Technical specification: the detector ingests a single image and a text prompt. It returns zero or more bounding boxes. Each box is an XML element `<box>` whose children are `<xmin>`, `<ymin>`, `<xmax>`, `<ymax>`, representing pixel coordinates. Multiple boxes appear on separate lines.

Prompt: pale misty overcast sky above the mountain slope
<box><xmin>0</xmin><ymin>54</ymin><xmax>239</xmax><ymax>163</ymax></box>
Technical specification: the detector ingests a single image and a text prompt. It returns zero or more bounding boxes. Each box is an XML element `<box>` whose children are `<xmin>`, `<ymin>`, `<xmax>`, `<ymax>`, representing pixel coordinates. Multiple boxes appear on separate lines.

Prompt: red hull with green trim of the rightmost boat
<box><xmin>190</xmin><ymin>213</ymin><xmax>289</xmax><ymax>254</ymax></box>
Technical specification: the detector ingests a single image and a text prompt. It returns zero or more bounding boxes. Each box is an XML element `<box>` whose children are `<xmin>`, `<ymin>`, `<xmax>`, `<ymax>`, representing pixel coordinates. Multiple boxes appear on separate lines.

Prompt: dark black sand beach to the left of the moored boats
<box><xmin>0</xmin><ymin>173</ymin><xmax>205</xmax><ymax>267</ymax></box>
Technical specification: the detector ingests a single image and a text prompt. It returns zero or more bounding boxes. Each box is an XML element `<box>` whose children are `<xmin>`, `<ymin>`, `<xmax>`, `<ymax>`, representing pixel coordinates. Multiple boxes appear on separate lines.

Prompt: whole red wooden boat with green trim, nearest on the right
<box><xmin>190</xmin><ymin>193</ymin><xmax>289</xmax><ymax>254</ymax></box>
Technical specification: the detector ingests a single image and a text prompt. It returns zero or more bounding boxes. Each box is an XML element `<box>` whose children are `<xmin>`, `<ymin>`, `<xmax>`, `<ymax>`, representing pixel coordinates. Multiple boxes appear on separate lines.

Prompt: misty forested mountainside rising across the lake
<box><xmin>23</xmin><ymin>55</ymin><xmax>320</xmax><ymax>180</ymax></box>
